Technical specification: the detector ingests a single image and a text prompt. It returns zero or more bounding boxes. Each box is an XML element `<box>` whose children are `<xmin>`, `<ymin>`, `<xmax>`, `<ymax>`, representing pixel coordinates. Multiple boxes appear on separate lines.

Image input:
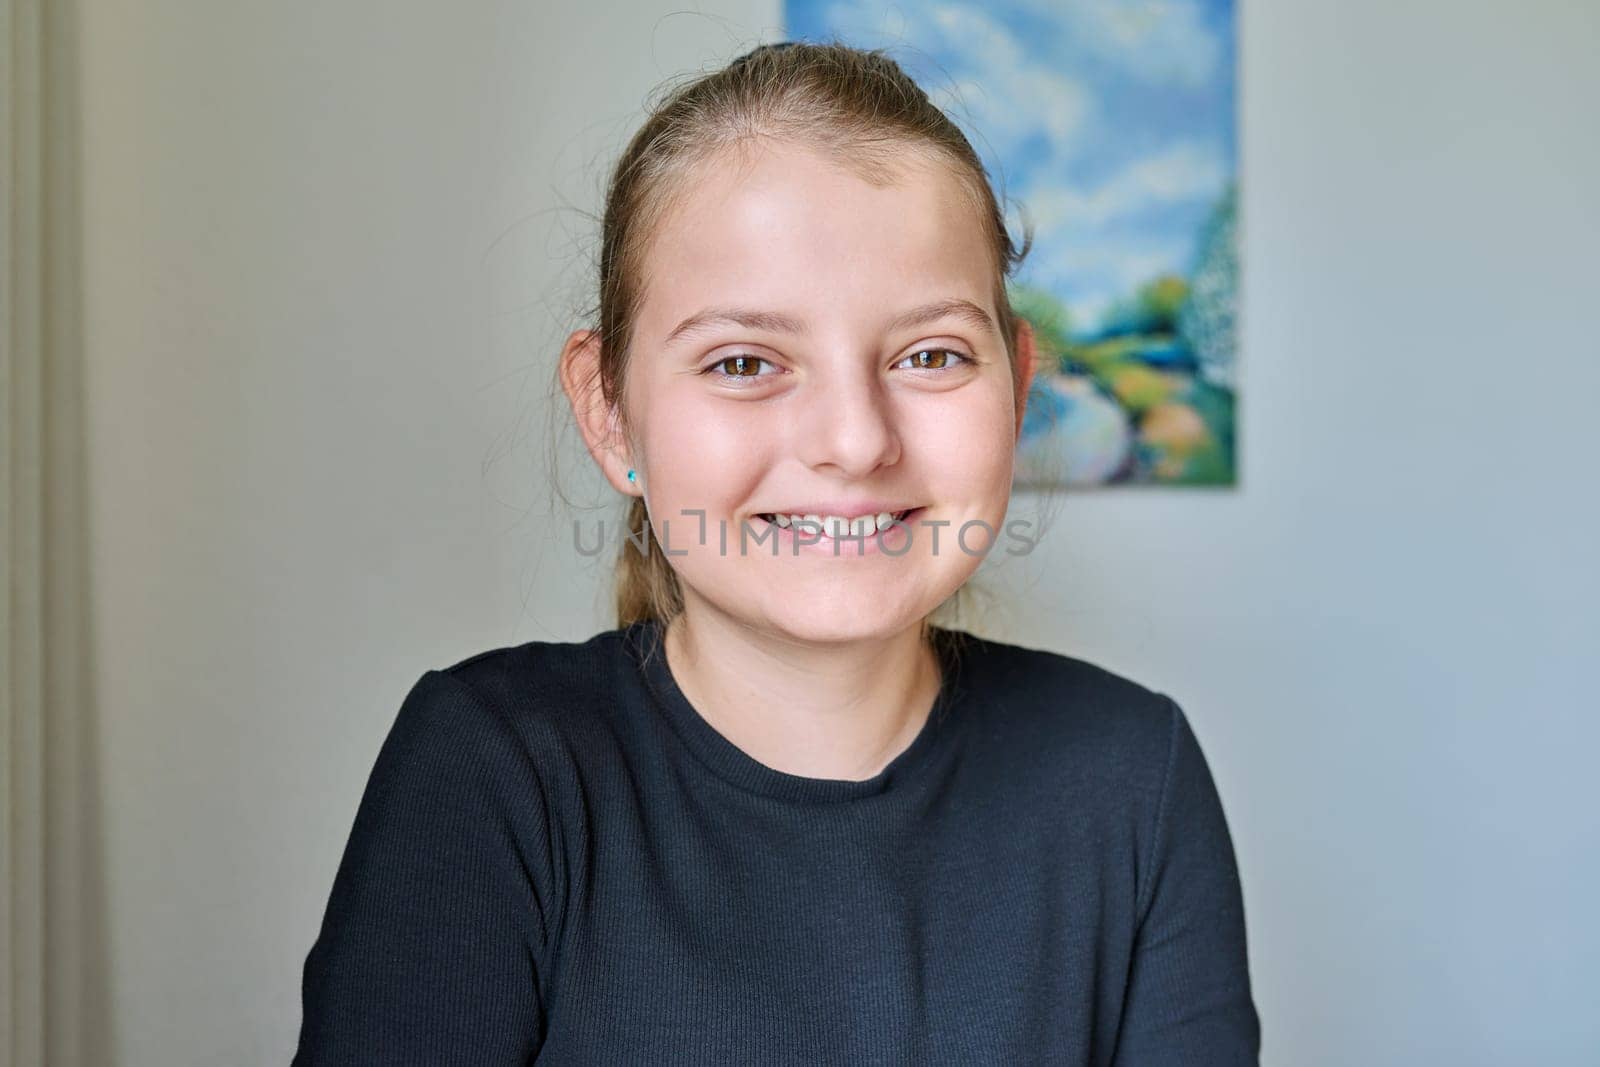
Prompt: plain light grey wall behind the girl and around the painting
<box><xmin>80</xmin><ymin>0</ymin><xmax>1600</xmax><ymax>1067</ymax></box>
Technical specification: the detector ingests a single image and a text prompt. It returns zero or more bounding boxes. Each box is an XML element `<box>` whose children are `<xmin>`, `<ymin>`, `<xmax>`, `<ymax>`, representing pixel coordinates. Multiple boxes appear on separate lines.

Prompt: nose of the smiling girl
<box><xmin>795</xmin><ymin>358</ymin><xmax>901</xmax><ymax>478</ymax></box>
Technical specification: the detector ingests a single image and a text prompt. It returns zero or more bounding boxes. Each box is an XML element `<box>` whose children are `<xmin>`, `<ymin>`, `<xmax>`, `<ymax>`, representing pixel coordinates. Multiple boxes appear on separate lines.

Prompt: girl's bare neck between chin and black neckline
<box><xmin>664</xmin><ymin>603</ymin><xmax>941</xmax><ymax>781</ymax></box>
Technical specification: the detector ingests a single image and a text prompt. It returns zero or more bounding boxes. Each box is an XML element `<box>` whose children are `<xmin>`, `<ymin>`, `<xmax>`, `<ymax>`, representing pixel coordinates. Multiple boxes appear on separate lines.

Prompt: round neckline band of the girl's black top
<box><xmin>622</xmin><ymin>619</ymin><xmax>965</xmax><ymax>803</ymax></box>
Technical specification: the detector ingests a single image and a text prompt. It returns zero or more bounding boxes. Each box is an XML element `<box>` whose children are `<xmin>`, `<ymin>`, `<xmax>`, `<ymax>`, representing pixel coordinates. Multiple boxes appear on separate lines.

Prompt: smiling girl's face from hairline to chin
<box><xmin>624</xmin><ymin>137</ymin><xmax>1032</xmax><ymax>643</ymax></box>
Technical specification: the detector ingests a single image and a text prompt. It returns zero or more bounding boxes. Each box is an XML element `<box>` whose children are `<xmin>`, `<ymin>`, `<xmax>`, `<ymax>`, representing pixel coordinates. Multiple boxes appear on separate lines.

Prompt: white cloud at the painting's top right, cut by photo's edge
<box><xmin>1013</xmin><ymin>0</ymin><xmax>1222</xmax><ymax>86</ymax></box>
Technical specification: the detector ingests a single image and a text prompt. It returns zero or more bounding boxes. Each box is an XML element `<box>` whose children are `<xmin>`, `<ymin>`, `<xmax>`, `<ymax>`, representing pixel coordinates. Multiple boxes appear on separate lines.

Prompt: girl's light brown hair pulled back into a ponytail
<box><xmin>576</xmin><ymin>40</ymin><xmax>1032</xmax><ymax>639</ymax></box>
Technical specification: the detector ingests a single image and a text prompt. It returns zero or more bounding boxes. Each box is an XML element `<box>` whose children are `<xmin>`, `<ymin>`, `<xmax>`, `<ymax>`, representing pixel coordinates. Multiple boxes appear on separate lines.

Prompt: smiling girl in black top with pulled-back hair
<box><xmin>294</xmin><ymin>43</ymin><xmax>1259</xmax><ymax>1064</ymax></box>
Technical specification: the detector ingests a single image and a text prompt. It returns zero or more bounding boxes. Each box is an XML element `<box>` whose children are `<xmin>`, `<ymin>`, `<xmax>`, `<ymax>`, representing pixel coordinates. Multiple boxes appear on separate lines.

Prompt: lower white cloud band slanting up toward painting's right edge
<box><xmin>1024</xmin><ymin>141</ymin><xmax>1229</xmax><ymax>232</ymax></box>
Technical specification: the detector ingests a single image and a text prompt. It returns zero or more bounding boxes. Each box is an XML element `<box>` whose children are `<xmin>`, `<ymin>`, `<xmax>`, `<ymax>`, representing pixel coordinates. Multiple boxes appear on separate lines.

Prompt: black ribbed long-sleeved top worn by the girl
<box><xmin>294</xmin><ymin>622</ymin><xmax>1261</xmax><ymax>1067</ymax></box>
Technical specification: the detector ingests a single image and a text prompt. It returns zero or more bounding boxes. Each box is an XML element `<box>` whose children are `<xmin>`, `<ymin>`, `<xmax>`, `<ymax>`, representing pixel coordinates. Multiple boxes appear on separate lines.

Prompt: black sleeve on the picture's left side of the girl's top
<box><xmin>293</xmin><ymin>670</ymin><xmax>550</xmax><ymax>1067</ymax></box>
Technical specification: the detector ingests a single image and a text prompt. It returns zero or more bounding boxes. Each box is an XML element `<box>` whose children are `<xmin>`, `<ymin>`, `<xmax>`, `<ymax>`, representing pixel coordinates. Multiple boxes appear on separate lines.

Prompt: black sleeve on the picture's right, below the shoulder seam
<box><xmin>1115</xmin><ymin>694</ymin><xmax>1261</xmax><ymax>1067</ymax></box>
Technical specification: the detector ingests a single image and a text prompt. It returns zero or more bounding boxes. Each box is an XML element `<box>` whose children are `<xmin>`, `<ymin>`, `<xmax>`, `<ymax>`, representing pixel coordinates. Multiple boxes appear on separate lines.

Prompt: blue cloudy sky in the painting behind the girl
<box><xmin>784</xmin><ymin>0</ymin><xmax>1237</xmax><ymax>330</ymax></box>
